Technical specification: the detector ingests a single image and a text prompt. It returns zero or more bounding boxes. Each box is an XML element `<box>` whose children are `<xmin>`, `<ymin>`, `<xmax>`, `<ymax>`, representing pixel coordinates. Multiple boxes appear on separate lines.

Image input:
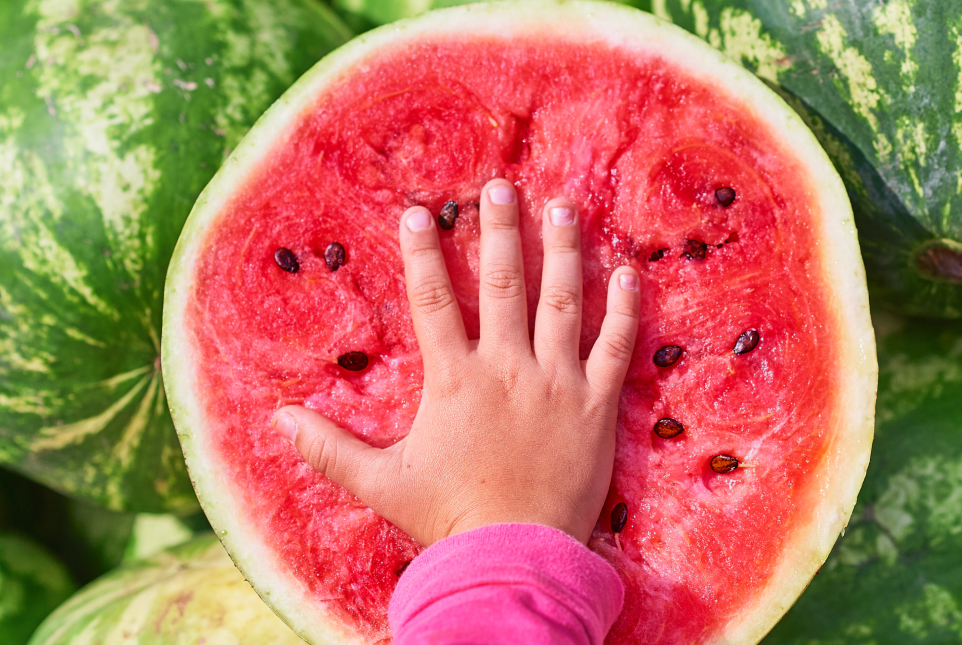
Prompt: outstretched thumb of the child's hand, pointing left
<box><xmin>272</xmin><ymin>405</ymin><xmax>386</xmax><ymax>505</ymax></box>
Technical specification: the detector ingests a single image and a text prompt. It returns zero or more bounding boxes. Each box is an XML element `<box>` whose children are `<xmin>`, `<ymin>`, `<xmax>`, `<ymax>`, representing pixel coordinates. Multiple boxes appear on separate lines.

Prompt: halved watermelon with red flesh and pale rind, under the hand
<box><xmin>163</xmin><ymin>2</ymin><xmax>877</xmax><ymax>644</ymax></box>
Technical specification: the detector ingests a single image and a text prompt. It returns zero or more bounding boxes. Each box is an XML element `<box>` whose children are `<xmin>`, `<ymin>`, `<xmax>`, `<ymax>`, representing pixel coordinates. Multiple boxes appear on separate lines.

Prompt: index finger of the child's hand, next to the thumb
<box><xmin>400</xmin><ymin>206</ymin><xmax>469</xmax><ymax>378</ymax></box>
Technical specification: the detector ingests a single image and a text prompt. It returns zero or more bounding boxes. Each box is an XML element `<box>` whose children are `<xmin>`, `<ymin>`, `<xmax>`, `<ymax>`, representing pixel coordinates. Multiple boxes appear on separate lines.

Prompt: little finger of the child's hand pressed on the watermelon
<box><xmin>585</xmin><ymin>267</ymin><xmax>641</xmax><ymax>397</ymax></box>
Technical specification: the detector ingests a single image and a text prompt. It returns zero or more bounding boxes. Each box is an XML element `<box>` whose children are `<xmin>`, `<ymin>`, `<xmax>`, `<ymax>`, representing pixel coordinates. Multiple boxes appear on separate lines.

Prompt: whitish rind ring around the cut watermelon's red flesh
<box><xmin>163</xmin><ymin>0</ymin><xmax>878</xmax><ymax>645</ymax></box>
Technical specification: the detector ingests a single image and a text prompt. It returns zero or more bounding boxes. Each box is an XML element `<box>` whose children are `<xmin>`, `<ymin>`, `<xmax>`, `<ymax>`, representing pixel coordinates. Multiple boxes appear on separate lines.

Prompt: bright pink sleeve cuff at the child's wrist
<box><xmin>388</xmin><ymin>524</ymin><xmax>624</xmax><ymax>645</ymax></box>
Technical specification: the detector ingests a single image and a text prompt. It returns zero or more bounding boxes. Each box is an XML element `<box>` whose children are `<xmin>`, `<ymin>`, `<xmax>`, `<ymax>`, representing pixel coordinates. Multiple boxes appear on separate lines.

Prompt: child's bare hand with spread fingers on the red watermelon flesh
<box><xmin>274</xmin><ymin>179</ymin><xmax>639</xmax><ymax>546</ymax></box>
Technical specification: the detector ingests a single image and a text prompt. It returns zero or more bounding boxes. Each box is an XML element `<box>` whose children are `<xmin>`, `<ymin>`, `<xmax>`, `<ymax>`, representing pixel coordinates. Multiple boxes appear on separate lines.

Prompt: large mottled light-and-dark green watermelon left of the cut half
<box><xmin>0</xmin><ymin>0</ymin><xmax>351</xmax><ymax>512</ymax></box>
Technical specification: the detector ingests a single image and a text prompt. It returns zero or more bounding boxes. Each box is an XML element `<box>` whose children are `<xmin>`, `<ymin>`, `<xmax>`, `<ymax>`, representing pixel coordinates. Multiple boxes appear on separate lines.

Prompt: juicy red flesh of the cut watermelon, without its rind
<box><xmin>188</xmin><ymin>36</ymin><xmax>838</xmax><ymax>643</ymax></box>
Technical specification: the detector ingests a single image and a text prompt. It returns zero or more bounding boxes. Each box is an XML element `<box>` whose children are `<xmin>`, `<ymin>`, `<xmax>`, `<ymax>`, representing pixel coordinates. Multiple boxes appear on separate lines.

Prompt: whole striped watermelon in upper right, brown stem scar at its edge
<box><xmin>651</xmin><ymin>0</ymin><xmax>962</xmax><ymax>318</ymax></box>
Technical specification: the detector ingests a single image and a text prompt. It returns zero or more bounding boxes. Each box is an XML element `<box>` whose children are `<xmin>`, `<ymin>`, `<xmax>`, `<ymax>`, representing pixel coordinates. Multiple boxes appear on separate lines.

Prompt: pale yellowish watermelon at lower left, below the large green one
<box><xmin>30</xmin><ymin>533</ymin><xmax>303</xmax><ymax>645</ymax></box>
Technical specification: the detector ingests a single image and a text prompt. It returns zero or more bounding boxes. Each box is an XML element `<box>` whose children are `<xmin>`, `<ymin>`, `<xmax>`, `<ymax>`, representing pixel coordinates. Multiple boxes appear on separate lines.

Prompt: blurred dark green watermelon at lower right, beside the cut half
<box><xmin>765</xmin><ymin>312</ymin><xmax>962</xmax><ymax>645</ymax></box>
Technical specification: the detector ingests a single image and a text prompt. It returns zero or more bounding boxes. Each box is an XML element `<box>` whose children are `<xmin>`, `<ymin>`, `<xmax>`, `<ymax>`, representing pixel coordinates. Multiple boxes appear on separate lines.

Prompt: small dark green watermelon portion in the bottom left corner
<box><xmin>0</xmin><ymin>533</ymin><xmax>74</xmax><ymax>645</ymax></box>
